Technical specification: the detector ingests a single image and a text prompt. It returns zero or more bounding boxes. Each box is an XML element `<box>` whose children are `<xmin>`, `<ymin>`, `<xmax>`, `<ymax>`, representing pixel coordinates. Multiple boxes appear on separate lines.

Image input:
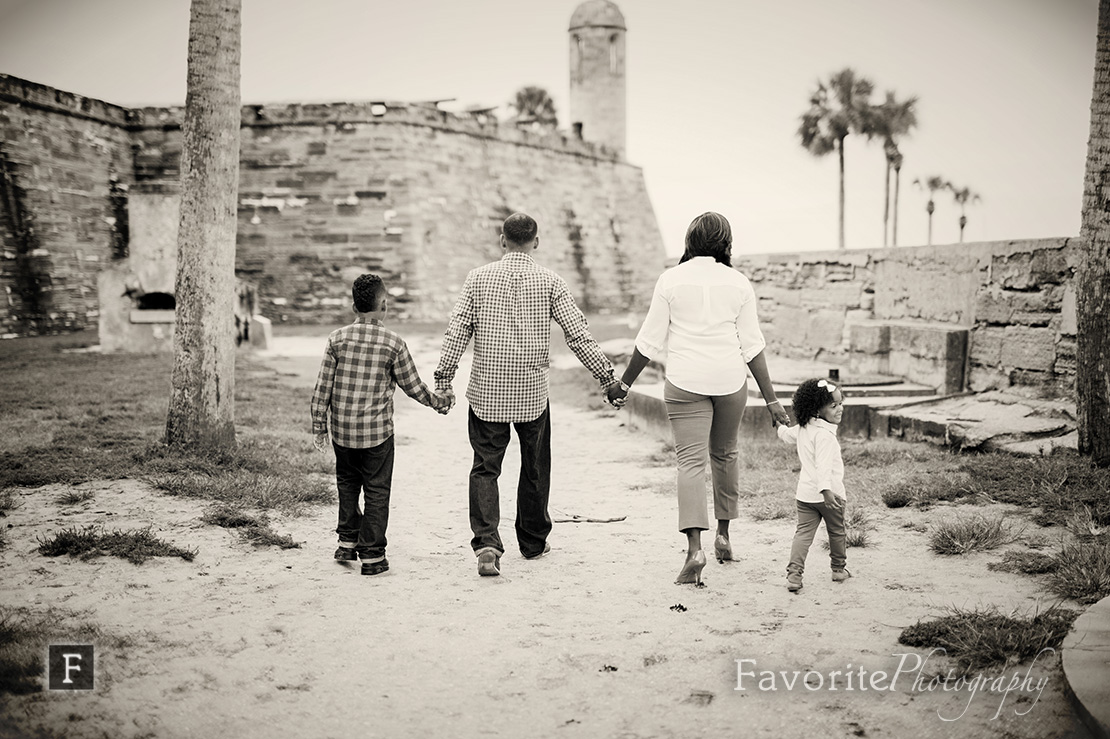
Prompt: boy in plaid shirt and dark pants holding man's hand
<box><xmin>312</xmin><ymin>274</ymin><xmax>450</xmax><ymax>575</ymax></box>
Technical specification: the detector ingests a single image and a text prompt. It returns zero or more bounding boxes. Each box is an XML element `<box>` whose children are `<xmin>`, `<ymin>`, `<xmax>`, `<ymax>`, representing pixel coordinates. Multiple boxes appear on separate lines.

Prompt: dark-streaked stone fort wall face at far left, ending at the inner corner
<box><xmin>0</xmin><ymin>74</ymin><xmax>133</xmax><ymax>337</ymax></box>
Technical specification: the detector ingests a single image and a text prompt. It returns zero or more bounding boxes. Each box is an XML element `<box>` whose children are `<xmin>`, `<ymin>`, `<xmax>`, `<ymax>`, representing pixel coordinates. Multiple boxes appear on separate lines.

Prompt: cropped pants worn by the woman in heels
<box><xmin>663</xmin><ymin>382</ymin><xmax>748</xmax><ymax>532</ymax></box>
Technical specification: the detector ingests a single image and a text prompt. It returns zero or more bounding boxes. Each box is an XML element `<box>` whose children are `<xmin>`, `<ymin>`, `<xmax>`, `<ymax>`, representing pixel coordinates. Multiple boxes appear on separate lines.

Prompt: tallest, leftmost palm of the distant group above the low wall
<box><xmin>798</xmin><ymin>67</ymin><xmax>875</xmax><ymax>249</ymax></box>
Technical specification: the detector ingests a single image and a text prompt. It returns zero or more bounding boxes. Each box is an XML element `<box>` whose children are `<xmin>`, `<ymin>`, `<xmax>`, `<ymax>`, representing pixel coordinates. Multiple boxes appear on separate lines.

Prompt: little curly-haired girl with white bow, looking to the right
<box><xmin>777</xmin><ymin>379</ymin><xmax>851</xmax><ymax>591</ymax></box>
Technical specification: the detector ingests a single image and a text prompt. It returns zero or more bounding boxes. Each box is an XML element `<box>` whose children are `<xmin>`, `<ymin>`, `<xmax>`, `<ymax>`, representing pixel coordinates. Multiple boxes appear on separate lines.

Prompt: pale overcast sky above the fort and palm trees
<box><xmin>0</xmin><ymin>0</ymin><xmax>1098</xmax><ymax>254</ymax></box>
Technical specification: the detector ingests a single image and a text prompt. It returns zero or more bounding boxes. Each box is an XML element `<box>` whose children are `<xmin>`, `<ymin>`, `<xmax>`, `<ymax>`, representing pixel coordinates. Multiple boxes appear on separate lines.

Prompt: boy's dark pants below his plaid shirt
<box><xmin>332</xmin><ymin>436</ymin><xmax>393</xmax><ymax>559</ymax></box>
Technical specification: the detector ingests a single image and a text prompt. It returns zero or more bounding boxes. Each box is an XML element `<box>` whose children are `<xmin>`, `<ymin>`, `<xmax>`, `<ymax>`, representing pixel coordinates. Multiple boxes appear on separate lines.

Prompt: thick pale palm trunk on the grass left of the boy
<box><xmin>165</xmin><ymin>0</ymin><xmax>241</xmax><ymax>448</ymax></box>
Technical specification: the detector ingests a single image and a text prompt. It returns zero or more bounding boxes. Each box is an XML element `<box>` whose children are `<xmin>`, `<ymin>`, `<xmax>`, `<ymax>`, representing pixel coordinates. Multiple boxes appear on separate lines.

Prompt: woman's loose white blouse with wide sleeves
<box><xmin>636</xmin><ymin>256</ymin><xmax>767</xmax><ymax>395</ymax></box>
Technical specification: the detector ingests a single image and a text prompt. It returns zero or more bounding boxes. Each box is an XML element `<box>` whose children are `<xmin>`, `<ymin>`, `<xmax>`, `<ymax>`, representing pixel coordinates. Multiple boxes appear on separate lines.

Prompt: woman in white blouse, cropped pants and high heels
<box><xmin>622</xmin><ymin>212</ymin><xmax>790</xmax><ymax>584</ymax></box>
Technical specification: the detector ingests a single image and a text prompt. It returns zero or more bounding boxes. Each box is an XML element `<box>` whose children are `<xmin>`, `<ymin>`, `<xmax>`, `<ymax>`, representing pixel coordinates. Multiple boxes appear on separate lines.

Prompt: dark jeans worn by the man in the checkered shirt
<box><xmin>470</xmin><ymin>406</ymin><xmax>552</xmax><ymax>557</ymax></box>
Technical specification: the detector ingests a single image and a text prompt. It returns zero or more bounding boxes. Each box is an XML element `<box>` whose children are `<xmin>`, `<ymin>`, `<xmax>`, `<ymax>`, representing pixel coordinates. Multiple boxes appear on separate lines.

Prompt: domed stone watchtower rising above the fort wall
<box><xmin>569</xmin><ymin>0</ymin><xmax>628</xmax><ymax>155</ymax></box>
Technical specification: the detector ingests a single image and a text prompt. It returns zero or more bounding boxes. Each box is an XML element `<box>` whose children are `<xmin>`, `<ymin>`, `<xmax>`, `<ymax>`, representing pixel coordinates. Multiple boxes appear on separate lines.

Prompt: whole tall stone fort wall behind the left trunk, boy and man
<box><xmin>0</xmin><ymin>75</ymin><xmax>664</xmax><ymax>336</ymax></box>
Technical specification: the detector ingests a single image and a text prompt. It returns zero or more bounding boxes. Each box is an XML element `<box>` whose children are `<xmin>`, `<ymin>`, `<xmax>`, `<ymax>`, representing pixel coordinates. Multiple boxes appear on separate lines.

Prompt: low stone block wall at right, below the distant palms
<box><xmin>734</xmin><ymin>239</ymin><xmax>1080</xmax><ymax>397</ymax></box>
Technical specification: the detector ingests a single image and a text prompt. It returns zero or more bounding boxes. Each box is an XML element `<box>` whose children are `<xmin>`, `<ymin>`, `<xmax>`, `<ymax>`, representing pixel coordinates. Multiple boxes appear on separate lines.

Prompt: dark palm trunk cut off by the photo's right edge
<box><xmin>1076</xmin><ymin>0</ymin><xmax>1110</xmax><ymax>467</ymax></box>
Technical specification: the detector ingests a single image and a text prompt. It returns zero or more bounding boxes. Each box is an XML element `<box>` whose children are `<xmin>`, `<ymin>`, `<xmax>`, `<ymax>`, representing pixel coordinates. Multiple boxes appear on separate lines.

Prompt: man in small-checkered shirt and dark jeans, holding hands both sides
<box><xmin>435</xmin><ymin>213</ymin><xmax>625</xmax><ymax>575</ymax></box>
